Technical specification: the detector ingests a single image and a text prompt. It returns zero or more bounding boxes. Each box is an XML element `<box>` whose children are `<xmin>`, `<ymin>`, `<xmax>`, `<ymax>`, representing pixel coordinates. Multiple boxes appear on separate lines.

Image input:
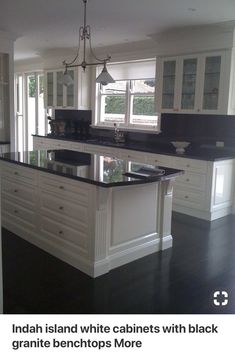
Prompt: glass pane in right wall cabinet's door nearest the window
<box><xmin>162</xmin><ymin>60</ymin><xmax>176</xmax><ymax>109</ymax></box>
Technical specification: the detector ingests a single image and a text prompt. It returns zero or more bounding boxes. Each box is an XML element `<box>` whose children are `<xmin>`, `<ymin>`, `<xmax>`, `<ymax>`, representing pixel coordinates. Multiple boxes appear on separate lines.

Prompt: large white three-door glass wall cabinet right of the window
<box><xmin>156</xmin><ymin>50</ymin><xmax>235</xmax><ymax>115</ymax></box>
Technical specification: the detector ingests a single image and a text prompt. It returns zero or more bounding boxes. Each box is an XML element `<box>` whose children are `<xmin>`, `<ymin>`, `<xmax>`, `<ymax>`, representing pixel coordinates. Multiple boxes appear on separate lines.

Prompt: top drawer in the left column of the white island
<box><xmin>1</xmin><ymin>162</ymin><xmax>37</xmax><ymax>185</ymax></box>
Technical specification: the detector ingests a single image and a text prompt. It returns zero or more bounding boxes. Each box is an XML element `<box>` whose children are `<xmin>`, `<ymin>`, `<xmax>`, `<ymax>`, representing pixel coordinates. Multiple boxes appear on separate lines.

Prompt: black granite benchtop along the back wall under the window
<box><xmin>32</xmin><ymin>135</ymin><xmax>235</xmax><ymax>161</ymax></box>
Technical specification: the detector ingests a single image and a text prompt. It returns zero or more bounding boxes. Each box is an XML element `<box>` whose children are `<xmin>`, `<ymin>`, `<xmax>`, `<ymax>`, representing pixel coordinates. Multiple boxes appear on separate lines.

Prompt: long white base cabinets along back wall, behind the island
<box><xmin>34</xmin><ymin>137</ymin><xmax>235</xmax><ymax>221</ymax></box>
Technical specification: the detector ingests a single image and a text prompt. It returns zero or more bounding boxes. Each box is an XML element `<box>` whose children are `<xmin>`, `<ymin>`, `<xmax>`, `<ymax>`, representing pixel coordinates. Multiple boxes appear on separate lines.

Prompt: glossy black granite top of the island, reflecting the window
<box><xmin>0</xmin><ymin>150</ymin><xmax>183</xmax><ymax>187</ymax></box>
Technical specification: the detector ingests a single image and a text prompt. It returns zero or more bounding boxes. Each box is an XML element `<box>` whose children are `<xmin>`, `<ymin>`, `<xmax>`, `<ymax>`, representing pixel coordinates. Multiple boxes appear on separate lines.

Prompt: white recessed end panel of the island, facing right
<box><xmin>95</xmin><ymin>182</ymin><xmax>169</xmax><ymax>272</ymax></box>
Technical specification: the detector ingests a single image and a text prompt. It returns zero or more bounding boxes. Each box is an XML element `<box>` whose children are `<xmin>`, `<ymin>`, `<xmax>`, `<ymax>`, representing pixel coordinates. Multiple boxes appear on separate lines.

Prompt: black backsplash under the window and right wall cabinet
<box><xmin>91</xmin><ymin>114</ymin><xmax>235</xmax><ymax>147</ymax></box>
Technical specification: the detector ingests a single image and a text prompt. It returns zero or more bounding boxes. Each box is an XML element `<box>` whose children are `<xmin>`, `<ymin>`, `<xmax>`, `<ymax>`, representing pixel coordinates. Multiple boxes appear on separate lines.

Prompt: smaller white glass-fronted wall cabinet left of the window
<box><xmin>45</xmin><ymin>68</ymin><xmax>90</xmax><ymax>110</ymax></box>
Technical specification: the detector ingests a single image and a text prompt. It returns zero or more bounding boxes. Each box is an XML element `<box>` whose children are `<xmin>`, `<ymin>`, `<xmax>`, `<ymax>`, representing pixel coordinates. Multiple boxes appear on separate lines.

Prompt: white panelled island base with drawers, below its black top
<box><xmin>0</xmin><ymin>161</ymin><xmax>173</xmax><ymax>277</ymax></box>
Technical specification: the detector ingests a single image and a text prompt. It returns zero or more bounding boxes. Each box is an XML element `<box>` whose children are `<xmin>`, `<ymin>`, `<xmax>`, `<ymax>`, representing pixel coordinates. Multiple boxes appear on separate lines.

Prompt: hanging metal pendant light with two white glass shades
<box><xmin>63</xmin><ymin>0</ymin><xmax>115</xmax><ymax>86</ymax></box>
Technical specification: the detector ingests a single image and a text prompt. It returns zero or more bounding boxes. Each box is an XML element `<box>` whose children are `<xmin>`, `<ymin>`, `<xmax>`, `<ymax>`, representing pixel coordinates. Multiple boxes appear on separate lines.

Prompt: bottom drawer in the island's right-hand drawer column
<box><xmin>41</xmin><ymin>216</ymin><xmax>87</xmax><ymax>252</ymax></box>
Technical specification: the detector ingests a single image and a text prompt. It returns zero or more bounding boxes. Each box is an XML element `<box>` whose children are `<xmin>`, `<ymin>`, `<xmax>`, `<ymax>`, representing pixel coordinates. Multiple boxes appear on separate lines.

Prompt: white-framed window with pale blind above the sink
<box><xmin>97</xmin><ymin>61</ymin><xmax>158</xmax><ymax>129</ymax></box>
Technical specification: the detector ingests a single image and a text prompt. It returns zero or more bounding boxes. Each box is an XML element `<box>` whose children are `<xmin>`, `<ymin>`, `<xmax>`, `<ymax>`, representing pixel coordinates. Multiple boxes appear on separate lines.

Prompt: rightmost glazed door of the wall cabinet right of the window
<box><xmin>200</xmin><ymin>53</ymin><xmax>226</xmax><ymax>114</ymax></box>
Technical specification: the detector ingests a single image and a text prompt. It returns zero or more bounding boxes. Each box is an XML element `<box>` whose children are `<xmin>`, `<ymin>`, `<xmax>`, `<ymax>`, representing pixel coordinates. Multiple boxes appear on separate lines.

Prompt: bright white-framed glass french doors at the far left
<box><xmin>15</xmin><ymin>72</ymin><xmax>47</xmax><ymax>151</ymax></box>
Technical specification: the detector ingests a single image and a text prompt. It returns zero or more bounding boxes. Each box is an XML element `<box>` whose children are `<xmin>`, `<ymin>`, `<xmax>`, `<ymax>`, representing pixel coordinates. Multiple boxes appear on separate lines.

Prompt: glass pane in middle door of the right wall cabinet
<box><xmin>181</xmin><ymin>58</ymin><xmax>198</xmax><ymax>110</ymax></box>
